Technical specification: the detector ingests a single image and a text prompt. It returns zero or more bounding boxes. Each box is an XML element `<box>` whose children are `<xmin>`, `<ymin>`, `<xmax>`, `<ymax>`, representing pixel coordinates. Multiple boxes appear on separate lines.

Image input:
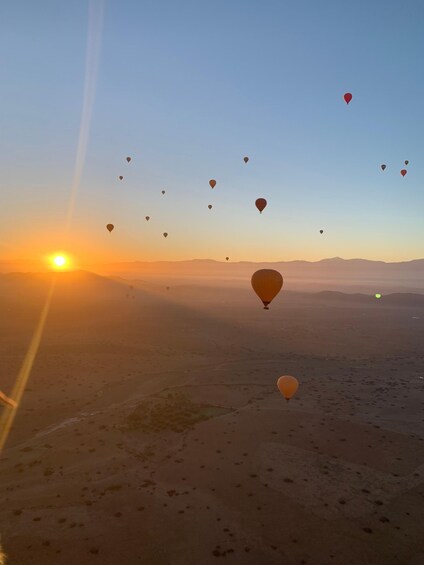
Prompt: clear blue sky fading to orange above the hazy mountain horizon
<box><xmin>0</xmin><ymin>0</ymin><xmax>424</xmax><ymax>266</ymax></box>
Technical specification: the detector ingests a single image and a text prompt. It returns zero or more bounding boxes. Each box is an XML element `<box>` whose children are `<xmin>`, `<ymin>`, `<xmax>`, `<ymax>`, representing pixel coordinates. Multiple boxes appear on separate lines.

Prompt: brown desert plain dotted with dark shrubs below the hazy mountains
<box><xmin>0</xmin><ymin>272</ymin><xmax>424</xmax><ymax>565</ymax></box>
